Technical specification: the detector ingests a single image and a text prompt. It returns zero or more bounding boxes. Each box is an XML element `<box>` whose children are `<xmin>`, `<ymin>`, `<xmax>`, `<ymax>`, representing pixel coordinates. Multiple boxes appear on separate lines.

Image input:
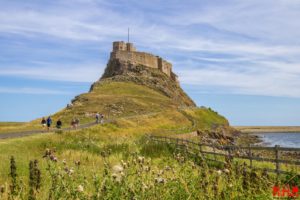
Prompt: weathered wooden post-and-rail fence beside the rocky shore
<box><xmin>149</xmin><ymin>135</ymin><xmax>300</xmax><ymax>174</ymax></box>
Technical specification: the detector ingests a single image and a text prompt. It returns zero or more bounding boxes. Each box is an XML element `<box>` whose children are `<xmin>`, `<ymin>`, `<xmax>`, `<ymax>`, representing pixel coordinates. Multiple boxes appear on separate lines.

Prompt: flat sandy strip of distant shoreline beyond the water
<box><xmin>234</xmin><ymin>126</ymin><xmax>300</xmax><ymax>133</ymax></box>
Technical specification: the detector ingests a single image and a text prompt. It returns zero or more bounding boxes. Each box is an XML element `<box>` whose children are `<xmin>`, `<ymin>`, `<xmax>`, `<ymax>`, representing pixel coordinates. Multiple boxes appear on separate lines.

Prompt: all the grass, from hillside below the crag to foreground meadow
<box><xmin>0</xmin><ymin>81</ymin><xmax>269</xmax><ymax>199</ymax></box>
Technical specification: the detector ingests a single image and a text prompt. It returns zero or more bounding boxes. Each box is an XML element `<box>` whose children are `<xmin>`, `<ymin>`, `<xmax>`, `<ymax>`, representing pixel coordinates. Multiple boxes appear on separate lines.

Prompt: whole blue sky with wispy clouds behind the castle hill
<box><xmin>0</xmin><ymin>0</ymin><xmax>300</xmax><ymax>125</ymax></box>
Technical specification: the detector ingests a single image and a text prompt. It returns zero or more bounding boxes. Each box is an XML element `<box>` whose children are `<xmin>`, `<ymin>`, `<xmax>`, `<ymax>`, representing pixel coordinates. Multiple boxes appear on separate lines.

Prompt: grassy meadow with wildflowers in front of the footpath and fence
<box><xmin>0</xmin><ymin>110</ymin><xmax>286</xmax><ymax>199</ymax></box>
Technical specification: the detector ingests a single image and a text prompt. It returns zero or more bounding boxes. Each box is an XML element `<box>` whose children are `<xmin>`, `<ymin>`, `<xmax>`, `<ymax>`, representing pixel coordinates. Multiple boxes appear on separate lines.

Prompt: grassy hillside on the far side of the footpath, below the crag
<box><xmin>0</xmin><ymin>81</ymin><xmax>227</xmax><ymax>133</ymax></box>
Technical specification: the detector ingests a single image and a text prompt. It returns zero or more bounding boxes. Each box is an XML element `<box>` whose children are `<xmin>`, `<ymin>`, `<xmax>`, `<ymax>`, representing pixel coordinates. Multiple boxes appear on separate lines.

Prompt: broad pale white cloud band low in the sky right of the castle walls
<box><xmin>179</xmin><ymin>62</ymin><xmax>300</xmax><ymax>98</ymax></box>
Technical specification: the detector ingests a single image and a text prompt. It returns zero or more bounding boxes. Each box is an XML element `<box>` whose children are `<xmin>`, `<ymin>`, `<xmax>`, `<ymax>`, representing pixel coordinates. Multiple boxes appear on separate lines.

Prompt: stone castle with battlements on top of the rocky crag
<box><xmin>110</xmin><ymin>41</ymin><xmax>178</xmax><ymax>82</ymax></box>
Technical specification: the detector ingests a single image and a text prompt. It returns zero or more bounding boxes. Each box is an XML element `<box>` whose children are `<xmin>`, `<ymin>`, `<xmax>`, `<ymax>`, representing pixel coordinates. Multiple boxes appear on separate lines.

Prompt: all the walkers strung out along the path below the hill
<box><xmin>41</xmin><ymin>113</ymin><xmax>104</xmax><ymax>131</ymax></box>
